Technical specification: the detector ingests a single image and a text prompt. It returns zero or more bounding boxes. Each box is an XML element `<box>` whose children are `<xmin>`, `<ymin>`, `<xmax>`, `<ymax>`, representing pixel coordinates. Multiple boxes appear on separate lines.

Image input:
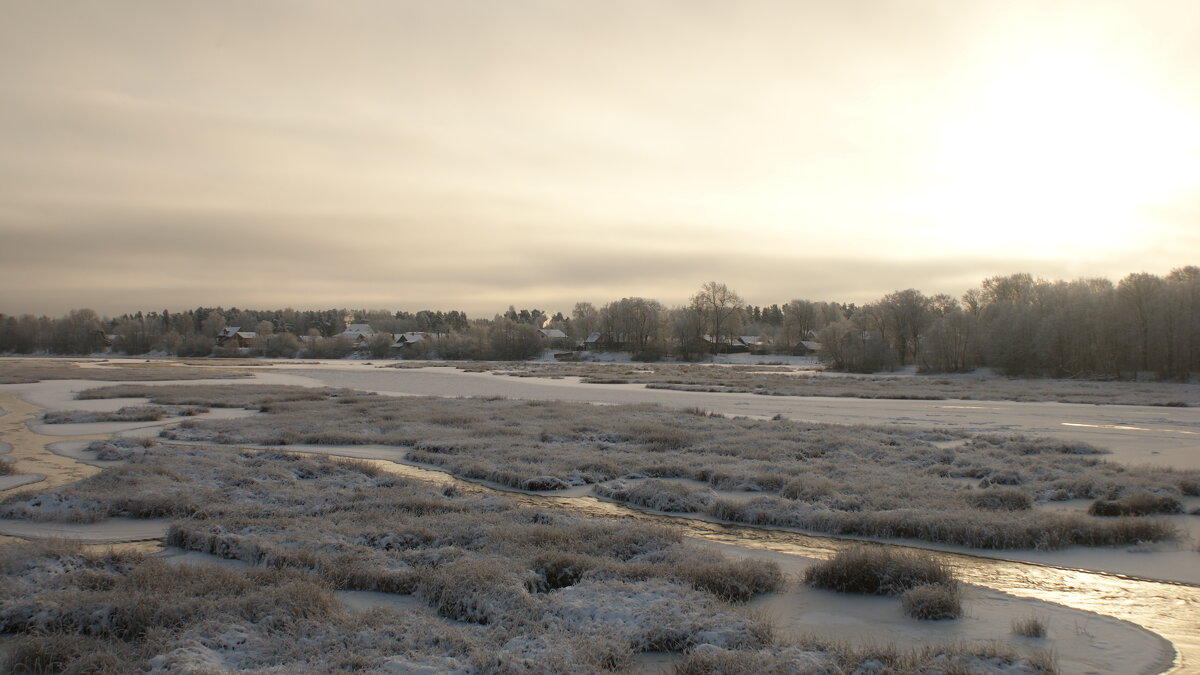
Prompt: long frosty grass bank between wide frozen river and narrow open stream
<box><xmin>163</xmin><ymin>387</ymin><xmax>1200</xmax><ymax>549</ymax></box>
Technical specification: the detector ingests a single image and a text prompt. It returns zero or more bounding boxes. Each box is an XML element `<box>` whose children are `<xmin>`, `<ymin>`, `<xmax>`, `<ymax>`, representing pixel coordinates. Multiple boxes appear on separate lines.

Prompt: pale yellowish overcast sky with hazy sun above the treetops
<box><xmin>0</xmin><ymin>0</ymin><xmax>1200</xmax><ymax>317</ymax></box>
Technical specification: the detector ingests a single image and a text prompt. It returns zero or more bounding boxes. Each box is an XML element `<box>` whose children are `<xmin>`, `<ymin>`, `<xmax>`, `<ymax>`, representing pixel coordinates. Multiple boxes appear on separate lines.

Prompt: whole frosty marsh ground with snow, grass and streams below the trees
<box><xmin>0</xmin><ymin>359</ymin><xmax>1200</xmax><ymax>673</ymax></box>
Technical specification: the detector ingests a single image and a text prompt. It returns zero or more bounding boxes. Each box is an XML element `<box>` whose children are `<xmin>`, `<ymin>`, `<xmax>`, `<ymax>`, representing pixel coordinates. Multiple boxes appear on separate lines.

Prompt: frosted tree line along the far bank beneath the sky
<box><xmin>0</xmin><ymin>265</ymin><xmax>1200</xmax><ymax>380</ymax></box>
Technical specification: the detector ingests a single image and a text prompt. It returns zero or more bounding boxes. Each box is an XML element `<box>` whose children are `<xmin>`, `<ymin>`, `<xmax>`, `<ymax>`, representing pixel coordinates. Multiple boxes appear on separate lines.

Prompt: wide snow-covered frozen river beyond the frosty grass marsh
<box><xmin>276</xmin><ymin>362</ymin><xmax>1200</xmax><ymax>468</ymax></box>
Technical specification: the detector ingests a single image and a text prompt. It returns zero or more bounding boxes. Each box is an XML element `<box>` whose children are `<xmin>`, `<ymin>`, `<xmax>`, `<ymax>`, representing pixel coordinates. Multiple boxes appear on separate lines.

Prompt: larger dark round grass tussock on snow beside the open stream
<box><xmin>804</xmin><ymin>546</ymin><xmax>954</xmax><ymax>596</ymax></box>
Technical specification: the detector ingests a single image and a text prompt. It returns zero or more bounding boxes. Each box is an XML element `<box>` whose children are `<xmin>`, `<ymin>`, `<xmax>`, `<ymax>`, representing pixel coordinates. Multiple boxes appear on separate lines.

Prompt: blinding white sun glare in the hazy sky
<box><xmin>911</xmin><ymin>50</ymin><xmax>1200</xmax><ymax>257</ymax></box>
